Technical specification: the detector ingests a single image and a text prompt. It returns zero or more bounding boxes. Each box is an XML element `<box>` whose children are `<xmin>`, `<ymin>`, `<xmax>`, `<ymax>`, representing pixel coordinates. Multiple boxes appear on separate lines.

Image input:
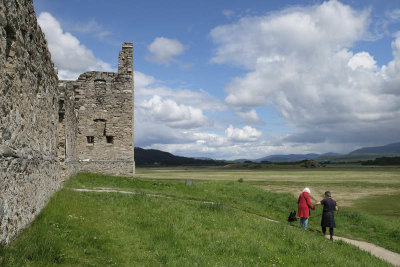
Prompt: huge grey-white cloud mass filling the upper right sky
<box><xmin>210</xmin><ymin>0</ymin><xmax>400</xmax><ymax>149</ymax></box>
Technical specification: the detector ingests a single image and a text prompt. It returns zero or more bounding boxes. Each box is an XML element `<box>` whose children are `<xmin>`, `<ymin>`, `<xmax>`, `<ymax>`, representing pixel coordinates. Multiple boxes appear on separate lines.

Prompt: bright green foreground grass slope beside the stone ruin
<box><xmin>0</xmin><ymin>174</ymin><xmax>398</xmax><ymax>266</ymax></box>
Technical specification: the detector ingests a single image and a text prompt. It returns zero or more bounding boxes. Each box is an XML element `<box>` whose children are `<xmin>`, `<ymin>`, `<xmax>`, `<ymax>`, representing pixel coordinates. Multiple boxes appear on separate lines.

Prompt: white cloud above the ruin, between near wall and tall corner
<box><xmin>38</xmin><ymin>12</ymin><xmax>111</xmax><ymax>79</ymax></box>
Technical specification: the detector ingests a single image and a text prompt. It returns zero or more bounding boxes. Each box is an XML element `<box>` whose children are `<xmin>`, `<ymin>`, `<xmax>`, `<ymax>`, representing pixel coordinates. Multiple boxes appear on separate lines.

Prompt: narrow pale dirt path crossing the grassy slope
<box><xmin>72</xmin><ymin>188</ymin><xmax>400</xmax><ymax>266</ymax></box>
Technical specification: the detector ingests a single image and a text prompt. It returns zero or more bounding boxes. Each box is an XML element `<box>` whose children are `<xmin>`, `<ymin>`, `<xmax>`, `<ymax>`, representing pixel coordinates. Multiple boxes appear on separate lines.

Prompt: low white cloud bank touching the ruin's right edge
<box><xmin>135</xmin><ymin>71</ymin><xmax>226</xmax><ymax>151</ymax></box>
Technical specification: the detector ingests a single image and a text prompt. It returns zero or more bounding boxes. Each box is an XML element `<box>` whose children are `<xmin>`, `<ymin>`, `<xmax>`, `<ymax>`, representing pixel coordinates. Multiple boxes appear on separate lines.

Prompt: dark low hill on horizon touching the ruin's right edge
<box><xmin>135</xmin><ymin>147</ymin><xmax>226</xmax><ymax>167</ymax></box>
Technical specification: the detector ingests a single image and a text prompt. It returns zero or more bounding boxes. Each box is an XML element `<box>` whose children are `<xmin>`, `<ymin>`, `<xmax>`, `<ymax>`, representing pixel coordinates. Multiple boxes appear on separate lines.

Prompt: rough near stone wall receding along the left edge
<box><xmin>0</xmin><ymin>0</ymin><xmax>61</xmax><ymax>243</ymax></box>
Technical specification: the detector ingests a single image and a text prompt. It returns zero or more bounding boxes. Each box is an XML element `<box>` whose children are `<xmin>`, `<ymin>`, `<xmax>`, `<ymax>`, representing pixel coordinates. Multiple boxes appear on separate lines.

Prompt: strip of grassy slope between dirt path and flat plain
<box><xmin>73</xmin><ymin>174</ymin><xmax>400</xmax><ymax>253</ymax></box>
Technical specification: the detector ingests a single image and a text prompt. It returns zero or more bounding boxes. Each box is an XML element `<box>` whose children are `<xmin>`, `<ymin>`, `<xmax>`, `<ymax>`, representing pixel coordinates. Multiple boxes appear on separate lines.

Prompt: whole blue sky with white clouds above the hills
<box><xmin>34</xmin><ymin>0</ymin><xmax>400</xmax><ymax>159</ymax></box>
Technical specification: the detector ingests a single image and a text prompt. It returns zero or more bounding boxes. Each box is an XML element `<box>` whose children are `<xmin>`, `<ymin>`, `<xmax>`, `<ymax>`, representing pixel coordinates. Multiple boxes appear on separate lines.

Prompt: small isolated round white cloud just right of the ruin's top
<box><xmin>147</xmin><ymin>37</ymin><xmax>185</xmax><ymax>66</ymax></box>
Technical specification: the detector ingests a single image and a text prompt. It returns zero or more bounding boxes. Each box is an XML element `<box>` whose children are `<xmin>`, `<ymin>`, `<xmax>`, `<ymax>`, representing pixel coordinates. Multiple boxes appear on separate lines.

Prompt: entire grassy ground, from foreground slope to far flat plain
<box><xmin>0</xmin><ymin>167</ymin><xmax>400</xmax><ymax>266</ymax></box>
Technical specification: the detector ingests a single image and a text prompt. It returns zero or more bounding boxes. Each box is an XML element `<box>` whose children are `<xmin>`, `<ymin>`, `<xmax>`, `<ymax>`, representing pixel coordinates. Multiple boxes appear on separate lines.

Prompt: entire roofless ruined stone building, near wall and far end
<box><xmin>0</xmin><ymin>0</ymin><xmax>135</xmax><ymax>243</ymax></box>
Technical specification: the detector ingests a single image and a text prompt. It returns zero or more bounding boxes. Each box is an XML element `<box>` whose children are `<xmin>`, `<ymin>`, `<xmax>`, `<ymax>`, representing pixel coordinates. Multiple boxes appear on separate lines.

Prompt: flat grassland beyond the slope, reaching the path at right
<box><xmin>137</xmin><ymin>165</ymin><xmax>400</xmax><ymax>252</ymax></box>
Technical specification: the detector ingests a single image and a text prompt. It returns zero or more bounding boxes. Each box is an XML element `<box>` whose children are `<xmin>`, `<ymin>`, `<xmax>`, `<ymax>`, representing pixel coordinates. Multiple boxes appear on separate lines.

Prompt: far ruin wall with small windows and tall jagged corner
<box><xmin>59</xmin><ymin>43</ymin><xmax>135</xmax><ymax>176</ymax></box>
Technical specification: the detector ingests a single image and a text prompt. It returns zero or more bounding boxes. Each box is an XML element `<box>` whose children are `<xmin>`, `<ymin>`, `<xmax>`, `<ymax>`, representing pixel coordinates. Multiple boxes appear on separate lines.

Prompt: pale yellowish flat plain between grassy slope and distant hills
<box><xmin>136</xmin><ymin>165</ymin><xmax>400</xmax><ymax>208</ymax></box>
